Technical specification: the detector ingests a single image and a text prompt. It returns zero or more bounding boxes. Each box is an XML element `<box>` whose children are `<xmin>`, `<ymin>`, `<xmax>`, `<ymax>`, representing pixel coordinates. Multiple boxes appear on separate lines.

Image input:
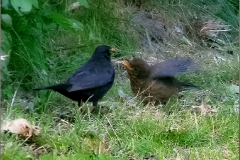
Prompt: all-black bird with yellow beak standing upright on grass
<box><xmin>35</xmin><ymin>45</ymin><xmax>115</xmax><ymax>107</ymax></box>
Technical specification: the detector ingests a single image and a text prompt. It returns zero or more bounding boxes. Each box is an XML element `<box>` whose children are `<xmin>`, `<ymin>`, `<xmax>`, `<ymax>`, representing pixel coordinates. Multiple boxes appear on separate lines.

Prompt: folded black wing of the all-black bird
<box><xmin>66</xmin><ymin>63</ymin><xmax>115</xmax><ymax>92</ymax></box>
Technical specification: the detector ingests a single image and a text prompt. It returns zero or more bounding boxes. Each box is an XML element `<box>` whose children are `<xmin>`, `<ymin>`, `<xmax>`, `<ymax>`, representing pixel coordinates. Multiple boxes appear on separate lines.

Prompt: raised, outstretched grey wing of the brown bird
<box><xmin>150</xmin><ymin>57</ymin><xmax>199</xmax><ymax>78</ymax></box>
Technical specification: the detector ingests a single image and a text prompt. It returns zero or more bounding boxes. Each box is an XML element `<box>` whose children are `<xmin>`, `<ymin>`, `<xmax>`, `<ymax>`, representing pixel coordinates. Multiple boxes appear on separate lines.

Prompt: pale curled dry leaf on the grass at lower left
<box><xmin>1</xmin><ymin>118</ymin><xmax>41</xmax><ymax>138</ymax></box>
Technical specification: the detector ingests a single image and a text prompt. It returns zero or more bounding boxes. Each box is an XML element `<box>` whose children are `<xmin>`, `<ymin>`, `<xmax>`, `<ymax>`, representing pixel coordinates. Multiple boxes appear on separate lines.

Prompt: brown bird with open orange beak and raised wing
<box><xmin>122</xmin><ymin>57</ymin><xmax>199</xmax><ymax>105</ymax></box>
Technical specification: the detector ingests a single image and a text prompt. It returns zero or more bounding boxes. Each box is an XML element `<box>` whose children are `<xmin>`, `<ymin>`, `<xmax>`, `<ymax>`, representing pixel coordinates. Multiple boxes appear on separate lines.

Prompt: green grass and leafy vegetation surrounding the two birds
<box><xmin>1</xmin><ymin>0</ymin><xmax>239</xmax><ymax>160</ymax></box>
